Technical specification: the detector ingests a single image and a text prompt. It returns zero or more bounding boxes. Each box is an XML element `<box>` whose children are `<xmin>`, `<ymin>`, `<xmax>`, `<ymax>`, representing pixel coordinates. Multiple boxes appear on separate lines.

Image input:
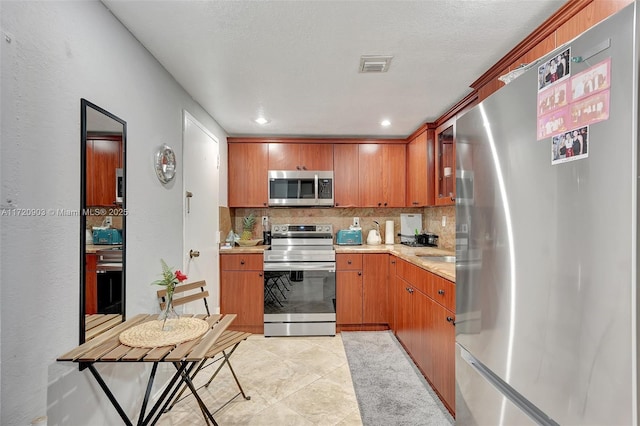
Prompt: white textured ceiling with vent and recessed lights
<box><xmin>103</xmin><ymin>0</ymin><xmax>565</xmax><ymax>137</ymax></box>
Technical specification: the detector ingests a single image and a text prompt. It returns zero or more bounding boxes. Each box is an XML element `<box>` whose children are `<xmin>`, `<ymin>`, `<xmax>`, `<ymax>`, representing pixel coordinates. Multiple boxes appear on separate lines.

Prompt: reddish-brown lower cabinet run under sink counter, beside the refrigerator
<box><xmin>391</xmin><ymin>256</ymin><xmax>455</xmax><ymax>413</ymax></box>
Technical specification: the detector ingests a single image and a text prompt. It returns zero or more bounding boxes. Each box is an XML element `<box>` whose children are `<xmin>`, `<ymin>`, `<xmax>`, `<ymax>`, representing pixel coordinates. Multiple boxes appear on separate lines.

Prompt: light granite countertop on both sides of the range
<box><xmin>220</xmin><ymin>244</ymin><xmax>456</xmax><ymax>282</ymax></box>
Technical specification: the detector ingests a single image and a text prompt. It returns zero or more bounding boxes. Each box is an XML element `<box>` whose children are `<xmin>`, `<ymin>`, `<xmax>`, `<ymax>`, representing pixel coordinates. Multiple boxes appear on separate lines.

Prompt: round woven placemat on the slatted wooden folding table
<box><xmin>120</xmin><ymin>318</ymin><xmax>209</xmax><ymax>348</ymax></box>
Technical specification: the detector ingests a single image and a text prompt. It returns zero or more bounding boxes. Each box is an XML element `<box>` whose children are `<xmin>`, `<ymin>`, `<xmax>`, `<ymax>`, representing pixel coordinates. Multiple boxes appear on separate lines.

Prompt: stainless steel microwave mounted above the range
<box><xmin>268</xmin><ymin>170</ymin><xmax>334</xmax><ymax>207</ymax></box>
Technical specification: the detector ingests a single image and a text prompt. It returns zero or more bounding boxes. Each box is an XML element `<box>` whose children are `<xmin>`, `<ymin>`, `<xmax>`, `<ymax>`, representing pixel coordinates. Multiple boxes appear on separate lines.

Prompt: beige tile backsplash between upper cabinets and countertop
<box><xmin>230</xmin><ymin>206</ymin><xmax>456</xmax><ymax>250</ymax></box>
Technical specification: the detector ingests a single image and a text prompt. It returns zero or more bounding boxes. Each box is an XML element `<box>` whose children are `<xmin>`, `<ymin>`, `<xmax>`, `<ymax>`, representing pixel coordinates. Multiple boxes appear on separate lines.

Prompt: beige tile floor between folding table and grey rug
<box><xmin>158</xmin><ymin>334</ymin><xmax>362</xmax><ymax>426</ymax></box>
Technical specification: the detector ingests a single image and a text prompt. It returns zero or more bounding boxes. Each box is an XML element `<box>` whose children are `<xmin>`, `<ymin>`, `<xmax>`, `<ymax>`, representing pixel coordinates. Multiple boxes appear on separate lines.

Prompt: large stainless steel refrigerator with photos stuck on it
<box><xmin>456</xmin><ymin>3</ymin><xmax>639</xmax><ymax>425</ymax></box>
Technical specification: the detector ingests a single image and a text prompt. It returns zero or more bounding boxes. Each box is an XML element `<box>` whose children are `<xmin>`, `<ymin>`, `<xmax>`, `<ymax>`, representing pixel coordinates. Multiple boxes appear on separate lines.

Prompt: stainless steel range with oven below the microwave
<box><xmin>264</xmin><ymin>224</ymin><xmax>336</xmax><ymax>336</ymax></box>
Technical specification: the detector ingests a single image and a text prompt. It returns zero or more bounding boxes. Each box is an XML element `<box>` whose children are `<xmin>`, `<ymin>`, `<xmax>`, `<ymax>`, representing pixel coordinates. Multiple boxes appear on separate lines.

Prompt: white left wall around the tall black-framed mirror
<box><xmin>0</xmin><ymin>0</ymin><xmax>227</xmax><ymax>426</ymax></box>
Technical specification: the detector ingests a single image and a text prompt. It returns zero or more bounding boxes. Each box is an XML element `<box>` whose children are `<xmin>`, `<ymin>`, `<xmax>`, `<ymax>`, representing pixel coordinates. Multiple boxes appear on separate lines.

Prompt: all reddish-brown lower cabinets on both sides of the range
<box><xmin>220</xmin><ymin>253</ymin><xmax>455</xmax><ymax>414</ymax></box>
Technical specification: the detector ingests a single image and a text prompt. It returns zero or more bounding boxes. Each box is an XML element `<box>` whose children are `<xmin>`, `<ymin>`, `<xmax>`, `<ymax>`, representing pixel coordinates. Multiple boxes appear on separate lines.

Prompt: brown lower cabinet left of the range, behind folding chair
<box><xmin>220</xmin><ymin>254</ymin><xmax>264</xmax><ymax>334</ymax></box>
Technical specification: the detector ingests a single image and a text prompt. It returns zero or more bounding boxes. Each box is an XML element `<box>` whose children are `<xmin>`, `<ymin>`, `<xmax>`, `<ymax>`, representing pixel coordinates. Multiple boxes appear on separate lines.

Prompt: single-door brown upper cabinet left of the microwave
<box><xmin>228</xmin><ymin>143</ymin><xmax>269</xmax><ymax>207</ymax></box>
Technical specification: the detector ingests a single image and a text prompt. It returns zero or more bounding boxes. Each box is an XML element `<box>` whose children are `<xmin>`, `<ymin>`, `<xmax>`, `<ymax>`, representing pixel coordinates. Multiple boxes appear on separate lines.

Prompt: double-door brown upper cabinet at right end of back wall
<box><xmin>358</xmin><ymin>144</ymin><xmax>407</xmax><ymax>207</ymax></box>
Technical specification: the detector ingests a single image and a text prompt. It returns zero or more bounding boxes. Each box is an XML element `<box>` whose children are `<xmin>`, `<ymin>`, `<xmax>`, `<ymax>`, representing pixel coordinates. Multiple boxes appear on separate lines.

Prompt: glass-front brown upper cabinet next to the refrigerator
<box><xmin>435</xmin><ymin>117</ymin><xmax>456</xmax><ymax>206</ymax></box>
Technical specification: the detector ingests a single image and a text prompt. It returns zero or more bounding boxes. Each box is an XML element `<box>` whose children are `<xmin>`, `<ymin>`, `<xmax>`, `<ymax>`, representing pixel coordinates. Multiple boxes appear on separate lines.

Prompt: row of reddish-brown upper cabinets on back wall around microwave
<box><xmin>228</xmin><ymin>142</ymin><xmax>404</xmax><ymax>207</ymax></box>
